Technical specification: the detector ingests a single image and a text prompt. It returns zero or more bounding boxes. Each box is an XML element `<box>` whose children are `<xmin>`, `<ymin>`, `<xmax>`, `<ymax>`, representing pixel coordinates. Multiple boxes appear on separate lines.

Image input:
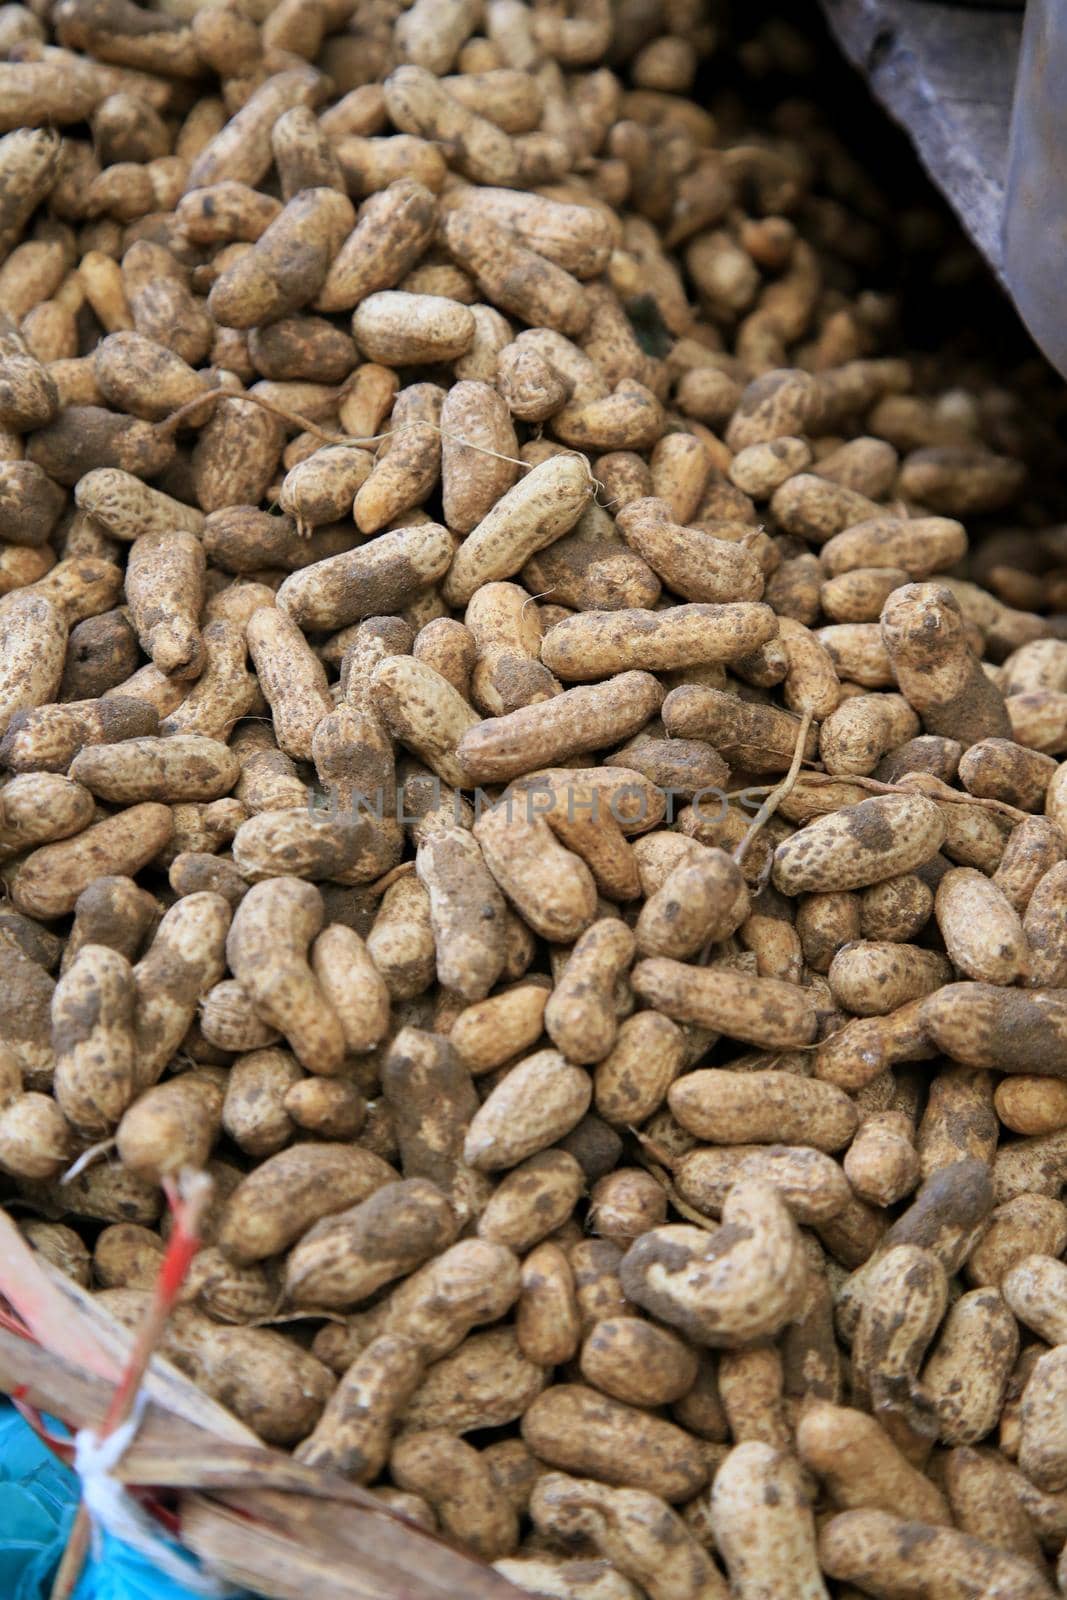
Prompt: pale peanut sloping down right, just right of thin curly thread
<box><xmin>616</xmin><ymin>499</ymin><xmax>763</xmax><ymax>603</ymax></box>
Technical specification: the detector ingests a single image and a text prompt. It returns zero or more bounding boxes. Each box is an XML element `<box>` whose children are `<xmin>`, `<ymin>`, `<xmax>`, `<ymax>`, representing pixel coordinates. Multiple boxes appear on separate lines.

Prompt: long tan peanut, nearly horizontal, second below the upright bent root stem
<box><xmin>632</xmin><ymin>957</ymin><xmax>816</xmax><ymax>1050</ymax></box>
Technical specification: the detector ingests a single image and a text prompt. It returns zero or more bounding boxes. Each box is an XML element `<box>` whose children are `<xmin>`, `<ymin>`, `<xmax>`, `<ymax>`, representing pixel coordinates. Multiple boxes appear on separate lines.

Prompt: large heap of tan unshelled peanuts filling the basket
<box><xmin>0</xmin><ymin>0</ymin><xmax>1067</xmax><ymax>1600</ymax></box>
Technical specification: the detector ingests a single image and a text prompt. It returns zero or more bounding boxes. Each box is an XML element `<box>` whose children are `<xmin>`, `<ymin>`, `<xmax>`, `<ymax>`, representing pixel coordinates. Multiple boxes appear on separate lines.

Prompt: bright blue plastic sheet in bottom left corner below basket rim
<box><xmin>0</xmin><ymin>1403</ymin><xmax>251</xmax><ymax>1600</ymax></box>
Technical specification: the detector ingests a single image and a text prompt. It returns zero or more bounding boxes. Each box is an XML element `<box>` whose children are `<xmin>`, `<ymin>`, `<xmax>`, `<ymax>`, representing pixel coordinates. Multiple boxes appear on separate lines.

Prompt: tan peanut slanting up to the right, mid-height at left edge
<box><xmin>10</xmin><ymin>803</ymin><xmax>173</xmax><ymax>918</ymax></box>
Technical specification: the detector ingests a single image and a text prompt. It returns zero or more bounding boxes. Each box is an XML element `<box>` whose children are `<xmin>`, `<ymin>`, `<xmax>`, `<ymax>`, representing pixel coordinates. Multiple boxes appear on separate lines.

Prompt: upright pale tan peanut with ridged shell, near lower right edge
<box><xmin>921</xmin><ymin>1286</ymin><xmax>1019</xmax><ymax>1445</ymax></box>
